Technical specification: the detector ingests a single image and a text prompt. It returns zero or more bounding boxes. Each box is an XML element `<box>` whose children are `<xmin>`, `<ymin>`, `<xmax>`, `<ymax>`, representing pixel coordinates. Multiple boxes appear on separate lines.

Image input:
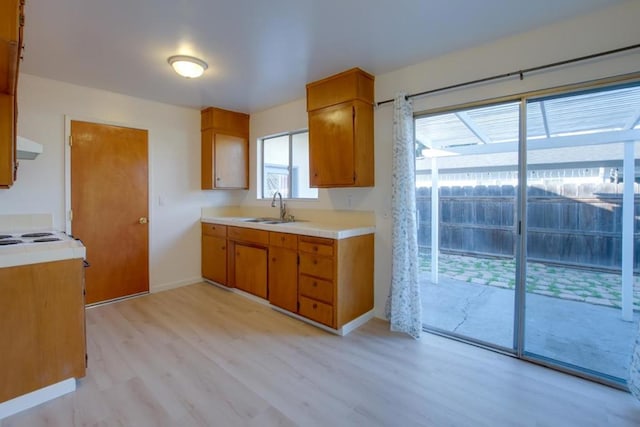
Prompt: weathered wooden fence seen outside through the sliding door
<box><xmin>416</xmin><ymin>183</ymin><xmax>640</xmax><ymax>272</ymax></box>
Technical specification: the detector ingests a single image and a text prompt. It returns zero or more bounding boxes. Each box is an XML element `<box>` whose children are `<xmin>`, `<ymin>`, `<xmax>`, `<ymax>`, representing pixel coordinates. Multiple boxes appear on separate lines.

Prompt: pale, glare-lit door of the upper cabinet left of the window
<box><xmin>214</xmin><ymin>133</ymin><xmax>249</xmax><ymax>188</ymax></box>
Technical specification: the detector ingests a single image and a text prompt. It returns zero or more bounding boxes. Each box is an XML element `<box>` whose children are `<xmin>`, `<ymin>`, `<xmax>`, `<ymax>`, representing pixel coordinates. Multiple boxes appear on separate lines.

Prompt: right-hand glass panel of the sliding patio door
<box><xmin>524</xmin><ymin>86</ymin><xmax>640</xmax><ymax>381</ymax></box>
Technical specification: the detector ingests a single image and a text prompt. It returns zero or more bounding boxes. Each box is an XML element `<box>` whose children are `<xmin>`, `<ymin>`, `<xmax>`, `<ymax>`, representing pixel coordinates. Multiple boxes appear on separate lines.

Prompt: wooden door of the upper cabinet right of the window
<box><xmin>309</xmin><ymin>102</ymin><xmax>355</xmax><ymax>187</ymax></box>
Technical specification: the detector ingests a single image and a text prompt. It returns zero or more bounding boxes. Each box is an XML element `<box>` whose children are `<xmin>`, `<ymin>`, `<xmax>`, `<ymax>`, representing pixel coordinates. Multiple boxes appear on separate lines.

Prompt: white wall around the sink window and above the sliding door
<box><xmin>243</xmin><ymin>1</ymin><xmax>640</xmax><ymax>316</ymax></box>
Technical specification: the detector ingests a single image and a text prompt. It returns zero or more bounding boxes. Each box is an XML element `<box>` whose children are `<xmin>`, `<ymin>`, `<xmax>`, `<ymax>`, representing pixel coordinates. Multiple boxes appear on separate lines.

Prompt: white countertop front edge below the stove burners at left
<box><xmin>0</xmin><ymin>239</ymin><xmax>86</xmax><ymax>268</ymax></box>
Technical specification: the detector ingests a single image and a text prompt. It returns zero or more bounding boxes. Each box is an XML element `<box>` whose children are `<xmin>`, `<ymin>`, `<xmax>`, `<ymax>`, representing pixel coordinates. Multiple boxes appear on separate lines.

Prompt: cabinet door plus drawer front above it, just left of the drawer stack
<box><xmin>269</xmin><ymin>232</ymin><xmax>298</xmax><ymax>313</ymax></box>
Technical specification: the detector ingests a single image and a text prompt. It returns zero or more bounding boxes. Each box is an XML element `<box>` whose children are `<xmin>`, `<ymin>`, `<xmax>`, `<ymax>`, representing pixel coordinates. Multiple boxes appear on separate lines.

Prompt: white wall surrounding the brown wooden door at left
<box><xmin>0</xmin><ymin>74</ymin><xmax>242</xmax><ymax>291</ymax></box>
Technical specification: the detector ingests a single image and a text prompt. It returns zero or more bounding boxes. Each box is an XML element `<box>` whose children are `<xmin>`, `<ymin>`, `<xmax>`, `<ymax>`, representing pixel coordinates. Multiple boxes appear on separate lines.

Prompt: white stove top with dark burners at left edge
<box><xmin>0</xmin><ymin>217</ymin><xmax>86</xmax><ymax>268</ymax></box>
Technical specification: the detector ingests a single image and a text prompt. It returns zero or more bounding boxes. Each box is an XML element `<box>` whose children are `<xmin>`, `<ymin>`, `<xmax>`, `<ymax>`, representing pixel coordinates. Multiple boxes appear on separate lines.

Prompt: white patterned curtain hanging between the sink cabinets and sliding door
<box><xmin>386</xmin><ymin>93</ymin><xmax>422</xmax><ymax>339</ymax></box>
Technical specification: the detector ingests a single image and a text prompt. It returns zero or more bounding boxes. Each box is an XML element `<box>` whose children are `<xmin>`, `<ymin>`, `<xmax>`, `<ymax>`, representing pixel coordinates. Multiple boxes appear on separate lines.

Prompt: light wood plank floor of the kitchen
<box><xmin>0</xmin><ymin>284</ymin><xmax>640</xmax><ymax>427</ymax></box>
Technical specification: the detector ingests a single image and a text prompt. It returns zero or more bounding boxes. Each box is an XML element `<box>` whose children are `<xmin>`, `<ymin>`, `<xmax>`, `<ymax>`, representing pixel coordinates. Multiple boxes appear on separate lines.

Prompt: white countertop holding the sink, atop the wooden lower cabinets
<box><xmin>201</xmin><ymin>216</ymin><xmax>376</xmax><ymax>239</ymax></box>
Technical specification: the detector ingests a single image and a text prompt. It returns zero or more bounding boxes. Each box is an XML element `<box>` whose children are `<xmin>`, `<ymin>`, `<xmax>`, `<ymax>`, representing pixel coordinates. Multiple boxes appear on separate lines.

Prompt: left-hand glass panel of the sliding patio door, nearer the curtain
<box><xmin>416</xmin><ymin>101</ymin><xmax>519</xmax><ymax>351</ymax></box>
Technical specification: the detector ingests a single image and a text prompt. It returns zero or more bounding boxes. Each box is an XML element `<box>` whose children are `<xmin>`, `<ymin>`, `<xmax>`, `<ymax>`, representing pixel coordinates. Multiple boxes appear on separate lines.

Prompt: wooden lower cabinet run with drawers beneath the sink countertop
<box><xmin>202</xmin><ymin>223</ymin><xmax>374</xmax><ymax>329</ymax></box>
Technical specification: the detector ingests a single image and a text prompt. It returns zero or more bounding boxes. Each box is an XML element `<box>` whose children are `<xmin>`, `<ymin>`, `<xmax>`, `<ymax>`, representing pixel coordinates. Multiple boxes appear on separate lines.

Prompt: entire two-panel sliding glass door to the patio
<box><xmin>415</xmin><ymin>78</ymin><xmax>640</xmax><ymax>384</ymax></box>
